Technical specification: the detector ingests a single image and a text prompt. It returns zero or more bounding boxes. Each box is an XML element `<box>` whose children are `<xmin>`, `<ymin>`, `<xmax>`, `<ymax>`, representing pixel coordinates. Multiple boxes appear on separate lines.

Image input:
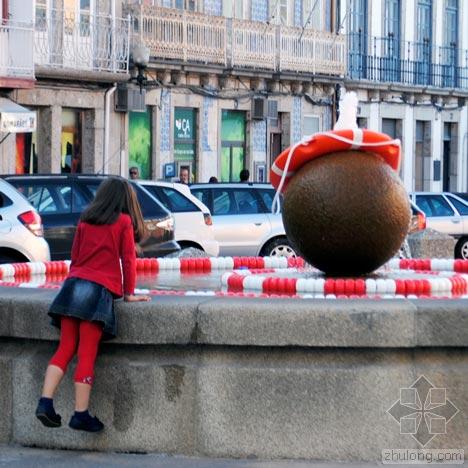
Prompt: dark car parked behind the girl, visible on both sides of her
<box><xmin>3</xmin><ymin>174</ymin><xmax>180</xmax><ymax>260</ymax></box>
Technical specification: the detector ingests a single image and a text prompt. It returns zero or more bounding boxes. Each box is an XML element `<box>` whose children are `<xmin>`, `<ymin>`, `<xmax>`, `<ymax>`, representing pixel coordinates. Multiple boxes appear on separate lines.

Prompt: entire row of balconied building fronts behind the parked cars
<box><xmin>0</xmin><ymin>0</ymin><xmax>468</xmax><ymax>191</ymax></box>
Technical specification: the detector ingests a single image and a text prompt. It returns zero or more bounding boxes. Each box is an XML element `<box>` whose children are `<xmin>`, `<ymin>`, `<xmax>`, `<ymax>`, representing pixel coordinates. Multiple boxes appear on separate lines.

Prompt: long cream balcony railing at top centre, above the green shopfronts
<box><xmin>126</xmin><ymin>5</ymin><xmax>346</xmax><ymax>76</ymax></box>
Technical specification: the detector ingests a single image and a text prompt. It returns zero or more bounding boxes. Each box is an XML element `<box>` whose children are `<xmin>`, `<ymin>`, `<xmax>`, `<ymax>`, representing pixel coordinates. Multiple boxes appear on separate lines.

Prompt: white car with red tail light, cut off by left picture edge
<box><xmin>0</xmin><ymin>179</ymin><xmax>50</xmax><ymax>263</ymax></box>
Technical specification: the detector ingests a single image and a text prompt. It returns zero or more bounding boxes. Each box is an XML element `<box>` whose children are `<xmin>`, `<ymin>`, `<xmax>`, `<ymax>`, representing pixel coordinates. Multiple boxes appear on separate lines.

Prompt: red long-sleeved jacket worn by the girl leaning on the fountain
<box><xmin>68</xmin><ymin>214</ymin><xmax>136</xmax><ymax>296</ymax></box>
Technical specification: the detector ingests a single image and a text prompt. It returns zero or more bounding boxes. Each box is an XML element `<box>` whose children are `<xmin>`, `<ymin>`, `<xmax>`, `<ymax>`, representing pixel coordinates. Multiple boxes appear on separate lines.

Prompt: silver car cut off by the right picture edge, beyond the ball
<box><xmin>410</xmin><ymin>192</ymin><xmax>468</xmax><ymax>259</ymax></box>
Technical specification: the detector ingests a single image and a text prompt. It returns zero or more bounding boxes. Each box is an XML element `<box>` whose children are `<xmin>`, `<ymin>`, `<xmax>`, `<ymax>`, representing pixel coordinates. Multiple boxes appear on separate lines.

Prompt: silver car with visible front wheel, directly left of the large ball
<box><xmin>190</xmin><ymin>183</ymin><xmax>296</xmax><ymax>257</ymax></box>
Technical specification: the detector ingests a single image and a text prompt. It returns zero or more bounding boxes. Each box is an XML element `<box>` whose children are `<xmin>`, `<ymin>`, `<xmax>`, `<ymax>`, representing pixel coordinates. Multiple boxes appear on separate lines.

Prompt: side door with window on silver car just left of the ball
<box><xmin>208</xmin><ymin>187</ymin><xmax>271</xmax><ymax>256</ymax></box>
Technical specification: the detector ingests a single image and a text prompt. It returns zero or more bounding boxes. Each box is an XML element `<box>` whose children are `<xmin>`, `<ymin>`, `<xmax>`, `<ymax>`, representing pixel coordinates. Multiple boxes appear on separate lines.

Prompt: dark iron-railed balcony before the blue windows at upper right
<box><xmin>348</xmin><ymin>34</ymin><xmax>468</xmax><ymax>89</ymax></box>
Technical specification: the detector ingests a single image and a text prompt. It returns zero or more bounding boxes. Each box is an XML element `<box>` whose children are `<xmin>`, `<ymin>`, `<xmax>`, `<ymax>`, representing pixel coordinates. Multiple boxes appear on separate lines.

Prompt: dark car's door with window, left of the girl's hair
<box><xmin>12</xmin><ymin>179</ymin><xmax>83</xmax><ymax>260</ymax></box>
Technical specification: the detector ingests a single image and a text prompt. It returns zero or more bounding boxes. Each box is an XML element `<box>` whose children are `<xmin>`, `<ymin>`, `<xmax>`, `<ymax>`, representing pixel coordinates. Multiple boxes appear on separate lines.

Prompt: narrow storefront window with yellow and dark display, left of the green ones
<box><xmin>60</xmin><ymin>109</ymin><xmax>83</xmax><ymax>173</ymax></box>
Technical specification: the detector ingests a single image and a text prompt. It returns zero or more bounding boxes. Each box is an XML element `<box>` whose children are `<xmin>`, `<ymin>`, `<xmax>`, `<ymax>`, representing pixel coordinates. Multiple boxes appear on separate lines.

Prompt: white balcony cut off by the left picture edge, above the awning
<box><xmin>0</xmin><ymin>21</ymin><xmax>34</xmax><ymax>88</ymax></box>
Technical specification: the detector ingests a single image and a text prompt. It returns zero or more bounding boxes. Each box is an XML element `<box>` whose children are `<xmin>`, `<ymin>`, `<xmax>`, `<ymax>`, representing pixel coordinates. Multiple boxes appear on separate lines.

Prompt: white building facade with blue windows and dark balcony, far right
<box><xmin>338</xmin><ymin>0</ymin><xmax>468</xmax><ymax>191</ymax></box>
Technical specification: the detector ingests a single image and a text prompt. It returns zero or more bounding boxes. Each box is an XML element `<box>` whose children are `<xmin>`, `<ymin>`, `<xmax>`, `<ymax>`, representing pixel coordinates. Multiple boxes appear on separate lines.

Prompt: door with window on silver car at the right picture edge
<box><xmin>415</xmin><ymin>193</ymin><xmax>463</xmax><ymax>236</ymax></box>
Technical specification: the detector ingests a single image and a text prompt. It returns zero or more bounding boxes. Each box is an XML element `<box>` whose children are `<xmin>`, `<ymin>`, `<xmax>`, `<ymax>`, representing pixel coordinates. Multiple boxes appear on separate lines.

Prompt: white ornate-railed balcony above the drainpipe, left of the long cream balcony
<box><xmin>34</xmin><ymin>10</ymin><xmax>130</xmax><ymax>73</ymax></box>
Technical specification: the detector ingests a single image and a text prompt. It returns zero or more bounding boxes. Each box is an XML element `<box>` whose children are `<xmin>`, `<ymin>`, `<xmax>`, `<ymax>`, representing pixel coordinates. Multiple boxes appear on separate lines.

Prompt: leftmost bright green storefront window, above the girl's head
<box><xmin>128</xmin><ymin>107</ymin><xmax>152</xmax><ymax>179</ymax></box>
